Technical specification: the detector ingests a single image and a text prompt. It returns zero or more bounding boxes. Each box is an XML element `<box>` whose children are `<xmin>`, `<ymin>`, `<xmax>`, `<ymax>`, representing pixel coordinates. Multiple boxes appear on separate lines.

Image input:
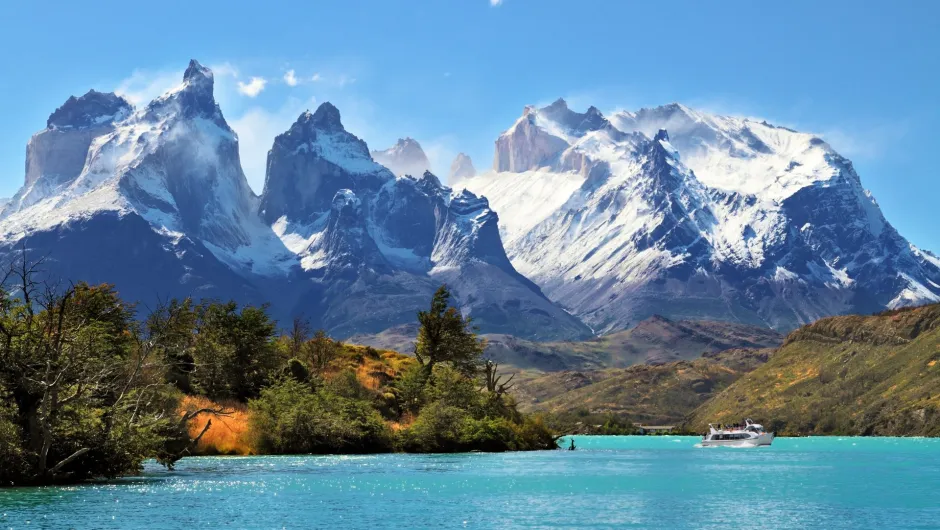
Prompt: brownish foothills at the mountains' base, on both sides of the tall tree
<box><xmin>347</xmin><ymin>316</ymin><xmax>783</xmax><ymax>372</ymax></box>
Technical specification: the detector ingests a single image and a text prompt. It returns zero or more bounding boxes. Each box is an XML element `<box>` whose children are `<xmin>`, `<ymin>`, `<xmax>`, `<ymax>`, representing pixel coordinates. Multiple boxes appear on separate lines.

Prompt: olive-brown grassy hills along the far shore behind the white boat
<box><xmin>514</xmin><ymin>304</ymin><xmax>940</xmax><ymax>436</ymax></box>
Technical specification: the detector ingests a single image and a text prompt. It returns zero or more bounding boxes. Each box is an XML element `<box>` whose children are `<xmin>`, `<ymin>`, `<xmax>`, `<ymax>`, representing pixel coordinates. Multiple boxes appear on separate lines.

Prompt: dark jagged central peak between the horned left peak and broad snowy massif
<box><xmin>260</xmin><ymin>104</ymin><xmax>589</xmax><ymax>337</ymax></box>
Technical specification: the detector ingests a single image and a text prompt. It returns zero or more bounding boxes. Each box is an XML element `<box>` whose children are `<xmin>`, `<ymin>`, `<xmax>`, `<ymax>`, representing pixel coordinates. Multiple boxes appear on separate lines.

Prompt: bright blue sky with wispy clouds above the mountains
<box><xmin>0</xmin><ymin>0</ymin><xmax>940</xmax><ymax>251</ymax></box>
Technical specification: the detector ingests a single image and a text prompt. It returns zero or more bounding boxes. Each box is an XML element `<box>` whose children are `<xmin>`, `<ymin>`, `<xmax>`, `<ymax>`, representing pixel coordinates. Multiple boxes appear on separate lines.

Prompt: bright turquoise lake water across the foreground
<box><xmin>0</xmin><ymin>436</ymin><xmax>940</xmax><ymax>529</ymax></box>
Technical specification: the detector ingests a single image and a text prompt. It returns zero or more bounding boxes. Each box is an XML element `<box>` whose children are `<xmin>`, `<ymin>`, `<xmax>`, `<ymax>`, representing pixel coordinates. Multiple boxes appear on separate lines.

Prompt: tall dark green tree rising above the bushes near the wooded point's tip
<box><xmin>414</xmin><ymin>285</ymin><xmax>486</xmax><ymax>379</ymax></box>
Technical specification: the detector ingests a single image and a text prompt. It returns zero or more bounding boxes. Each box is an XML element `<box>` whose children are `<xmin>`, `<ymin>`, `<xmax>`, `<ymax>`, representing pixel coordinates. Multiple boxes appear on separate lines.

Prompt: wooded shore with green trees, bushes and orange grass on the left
<box><xmin>0</xmin><ymin>253</ymin><xmax>558</xmax><ymax>486</ymax></box>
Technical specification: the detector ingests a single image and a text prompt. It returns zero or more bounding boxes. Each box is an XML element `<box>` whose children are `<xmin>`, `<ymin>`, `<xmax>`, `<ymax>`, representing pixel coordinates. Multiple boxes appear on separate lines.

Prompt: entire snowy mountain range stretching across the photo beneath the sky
<box><xmin>0</xmin><ymin>61</ymin><xmax>940</xmax><ymax>341</ymax></box>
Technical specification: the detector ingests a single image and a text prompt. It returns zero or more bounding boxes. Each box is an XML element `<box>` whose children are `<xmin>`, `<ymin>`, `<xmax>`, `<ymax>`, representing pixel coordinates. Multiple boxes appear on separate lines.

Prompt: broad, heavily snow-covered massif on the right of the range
<box><xmin>460</xmin><ymin>100</ymin><xmax>940</xmax><ymax>330</ymax></box>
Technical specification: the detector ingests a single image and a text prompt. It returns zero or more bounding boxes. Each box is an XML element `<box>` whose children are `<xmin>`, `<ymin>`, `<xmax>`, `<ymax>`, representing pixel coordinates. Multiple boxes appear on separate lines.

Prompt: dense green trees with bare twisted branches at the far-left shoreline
<box><xmin>0</xmin><ymin>255</ymin><xmax>178</xmax><ymax>483</ymax></box>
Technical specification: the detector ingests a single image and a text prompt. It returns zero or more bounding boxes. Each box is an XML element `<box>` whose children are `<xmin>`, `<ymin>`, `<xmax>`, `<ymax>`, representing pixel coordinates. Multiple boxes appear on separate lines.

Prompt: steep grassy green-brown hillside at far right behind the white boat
<box><xmin>687</xmin><ymin>304</ymin><xmax>940</xmax><ymax>436</ymax></box>
